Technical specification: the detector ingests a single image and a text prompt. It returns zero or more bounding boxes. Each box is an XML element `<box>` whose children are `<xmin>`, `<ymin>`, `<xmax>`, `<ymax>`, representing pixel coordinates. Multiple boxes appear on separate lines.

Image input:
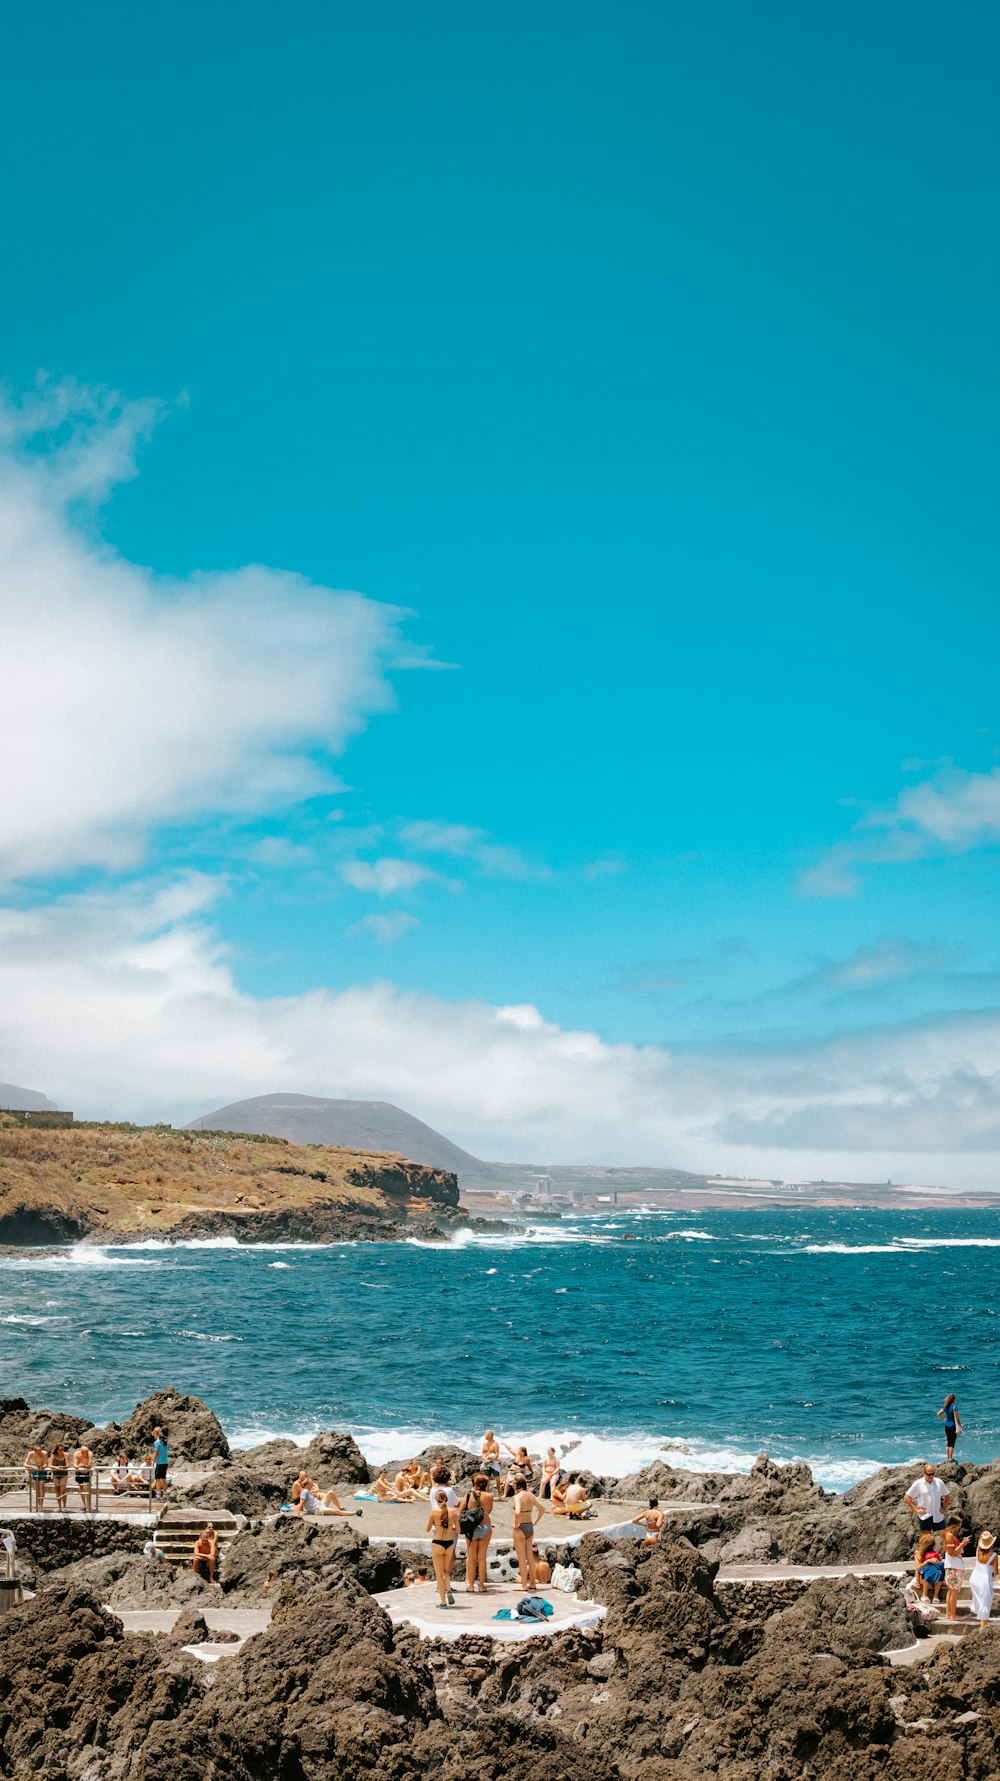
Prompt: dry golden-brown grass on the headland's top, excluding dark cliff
<box><xmin>0</xmin><ymin>1115</ymin><xmax>431</xmax><ymax>1232</ymax></box>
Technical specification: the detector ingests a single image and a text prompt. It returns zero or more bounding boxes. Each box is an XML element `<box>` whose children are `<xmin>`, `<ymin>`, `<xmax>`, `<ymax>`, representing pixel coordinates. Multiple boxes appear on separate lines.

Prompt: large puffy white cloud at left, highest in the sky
<box><xmin>0</xmin><ymin>386</ymin><xmax>417</xmax><ymax>876</ymax></box>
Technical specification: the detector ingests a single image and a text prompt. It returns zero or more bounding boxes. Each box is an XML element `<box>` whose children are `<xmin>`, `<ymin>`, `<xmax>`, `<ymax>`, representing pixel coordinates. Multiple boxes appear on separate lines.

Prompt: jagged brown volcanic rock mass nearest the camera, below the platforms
<box><xmin>13</xmin><ymin>1523</ymin><xmax>1000</xmax><ymax>1781</ymax></box>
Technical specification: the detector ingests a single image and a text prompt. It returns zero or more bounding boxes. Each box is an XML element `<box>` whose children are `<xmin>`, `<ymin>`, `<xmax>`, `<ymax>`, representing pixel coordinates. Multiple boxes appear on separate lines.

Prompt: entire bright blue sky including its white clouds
<box><xmin>0</xmin><ymin>4</ymin><xmax>1000</xmax><ymax>1184</ymax></box>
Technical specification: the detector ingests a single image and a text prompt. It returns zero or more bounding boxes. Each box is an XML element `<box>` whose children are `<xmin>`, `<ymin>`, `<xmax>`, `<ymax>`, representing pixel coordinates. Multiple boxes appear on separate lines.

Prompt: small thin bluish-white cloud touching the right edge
<box><xmin>797</xmin><ymin>766</ymin><xmax>1000</xmax><ymax>898</ymax></box>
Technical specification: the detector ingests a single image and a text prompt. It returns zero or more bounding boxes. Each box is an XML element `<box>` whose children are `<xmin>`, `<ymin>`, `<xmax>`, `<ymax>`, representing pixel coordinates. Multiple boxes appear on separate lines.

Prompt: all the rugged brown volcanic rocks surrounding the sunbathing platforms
<box><xmin>0</xmin><ymin>1393</ymin><xmax>1000</xmax><ymax>1781</ymax></box>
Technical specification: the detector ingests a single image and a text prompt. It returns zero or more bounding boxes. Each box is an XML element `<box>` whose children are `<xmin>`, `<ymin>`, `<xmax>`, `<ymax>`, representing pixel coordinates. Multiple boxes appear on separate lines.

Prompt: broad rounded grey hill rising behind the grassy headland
<box><xmin>187</xmin><ymin>1094</ymin><xmax>483</xmax><ymax>1174</ymax></box>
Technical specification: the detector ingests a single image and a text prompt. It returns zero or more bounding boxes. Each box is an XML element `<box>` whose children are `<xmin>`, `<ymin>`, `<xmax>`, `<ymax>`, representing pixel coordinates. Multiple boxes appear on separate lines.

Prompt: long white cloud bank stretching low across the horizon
<box><xmin>0</xmin><ymin>874</ymin><xmax>1000</xmax><ymax>1186</ymax></box>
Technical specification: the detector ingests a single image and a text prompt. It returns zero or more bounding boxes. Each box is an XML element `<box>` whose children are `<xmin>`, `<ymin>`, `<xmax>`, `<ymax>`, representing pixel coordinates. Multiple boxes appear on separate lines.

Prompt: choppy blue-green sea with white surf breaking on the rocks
<box><xmin>0</xmin><ymin>1208</ymin><xmax>1000</xmax><ymax>1489</ymax></box>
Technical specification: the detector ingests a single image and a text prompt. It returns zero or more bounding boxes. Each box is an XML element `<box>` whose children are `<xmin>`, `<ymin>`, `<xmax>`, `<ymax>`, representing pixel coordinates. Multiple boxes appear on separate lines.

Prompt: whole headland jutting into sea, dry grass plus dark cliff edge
<box><xmin>0</xmin><ymin>1115</ymin><xmax>458</xmax><ymax>1243</ymax></box>
